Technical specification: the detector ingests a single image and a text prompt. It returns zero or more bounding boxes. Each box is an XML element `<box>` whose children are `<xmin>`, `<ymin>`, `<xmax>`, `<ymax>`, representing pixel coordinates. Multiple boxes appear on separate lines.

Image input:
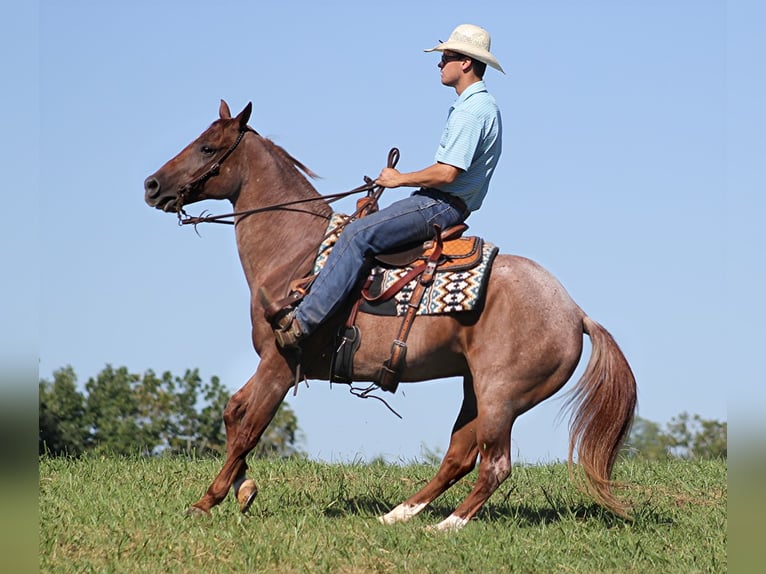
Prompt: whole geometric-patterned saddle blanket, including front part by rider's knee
<box><xmin>314</xmin><ymin>214</ymin><xmax>498</xmax><ymax>316</ymax></box>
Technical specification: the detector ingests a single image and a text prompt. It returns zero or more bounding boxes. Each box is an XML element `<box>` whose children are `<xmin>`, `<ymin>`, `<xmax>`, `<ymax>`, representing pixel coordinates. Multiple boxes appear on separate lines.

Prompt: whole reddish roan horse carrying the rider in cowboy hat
<box><xmin>144</xmin><ymin>100</ymin><xmax>637</xmax><ymax>531</ymax></box>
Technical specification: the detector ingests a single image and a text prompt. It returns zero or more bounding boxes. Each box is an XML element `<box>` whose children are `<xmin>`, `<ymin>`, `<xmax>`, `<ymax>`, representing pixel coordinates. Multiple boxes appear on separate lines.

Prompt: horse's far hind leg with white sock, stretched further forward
<box><xmin>378</xmin><ymin>375</ymin><xmax>479</xmax><ymax>524</ymax></box>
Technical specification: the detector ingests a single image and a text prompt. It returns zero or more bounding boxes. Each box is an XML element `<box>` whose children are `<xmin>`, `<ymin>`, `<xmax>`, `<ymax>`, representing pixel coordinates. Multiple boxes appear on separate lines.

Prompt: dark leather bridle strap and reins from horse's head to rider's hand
<box><xmin>176</xmin><ymin>127</ymin><xmax>399</xmax><ymax>228</ymax></box>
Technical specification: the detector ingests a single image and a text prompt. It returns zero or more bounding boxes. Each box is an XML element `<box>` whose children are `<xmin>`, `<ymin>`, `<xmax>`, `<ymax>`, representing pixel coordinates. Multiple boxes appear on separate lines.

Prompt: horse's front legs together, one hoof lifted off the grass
<box><xmin>188</xmin><ymin>355</ymin><xmax>292</xmax><ymax>514</ymax></box>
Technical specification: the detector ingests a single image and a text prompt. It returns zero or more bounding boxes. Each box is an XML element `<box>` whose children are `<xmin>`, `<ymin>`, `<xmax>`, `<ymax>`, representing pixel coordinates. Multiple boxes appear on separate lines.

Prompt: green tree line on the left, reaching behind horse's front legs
<box><xmin>38</xmin><ymin>365</ymin><xmax>304</xmax><ymax>457</ymax></box>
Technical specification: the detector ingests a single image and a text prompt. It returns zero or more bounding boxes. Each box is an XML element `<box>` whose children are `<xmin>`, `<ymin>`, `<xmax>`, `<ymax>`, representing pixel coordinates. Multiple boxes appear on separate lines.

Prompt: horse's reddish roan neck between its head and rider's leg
<box><xmin>234</xmin><ymin>138</ymin><xmax>331</xmax><ymax>296</ymax></box>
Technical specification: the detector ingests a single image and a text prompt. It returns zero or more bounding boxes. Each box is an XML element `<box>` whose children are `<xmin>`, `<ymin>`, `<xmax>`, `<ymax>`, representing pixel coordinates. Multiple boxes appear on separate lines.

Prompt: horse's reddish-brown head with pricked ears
<box><xmin>144</xmin><ymin>100</ymin><xmax>253</xmax><ymax>212</ymax></box>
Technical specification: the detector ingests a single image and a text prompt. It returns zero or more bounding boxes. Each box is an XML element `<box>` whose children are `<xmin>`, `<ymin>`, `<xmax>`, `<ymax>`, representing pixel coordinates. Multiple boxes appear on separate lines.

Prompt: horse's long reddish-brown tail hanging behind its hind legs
<box><xmin>566</xmin><ymin>316</ymin><xmax>637</xmax><ymax>517</ymax></box>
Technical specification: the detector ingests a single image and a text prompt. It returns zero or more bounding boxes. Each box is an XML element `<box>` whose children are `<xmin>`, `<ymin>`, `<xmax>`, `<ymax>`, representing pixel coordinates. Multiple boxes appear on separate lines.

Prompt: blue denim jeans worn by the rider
<box><xmin>295</xmin><ymin>189</ymin><xmax>468</xmax><ymax>334</ymax></box>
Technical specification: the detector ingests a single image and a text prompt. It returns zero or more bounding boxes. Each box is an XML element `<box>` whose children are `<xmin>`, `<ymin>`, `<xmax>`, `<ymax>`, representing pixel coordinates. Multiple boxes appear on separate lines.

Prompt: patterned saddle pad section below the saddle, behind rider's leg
<box><xmin>359</xmin><ymin>241</ymin><xmax>498</xmax><ymax>316</ymax></box>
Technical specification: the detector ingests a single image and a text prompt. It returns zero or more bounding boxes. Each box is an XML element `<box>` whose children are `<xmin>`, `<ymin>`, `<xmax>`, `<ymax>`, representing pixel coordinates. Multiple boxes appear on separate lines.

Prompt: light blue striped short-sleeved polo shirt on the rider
<box><xmin>436</xmin><ymin>80</ymin><xmax>503</xmax><ymax>211</ymax></box>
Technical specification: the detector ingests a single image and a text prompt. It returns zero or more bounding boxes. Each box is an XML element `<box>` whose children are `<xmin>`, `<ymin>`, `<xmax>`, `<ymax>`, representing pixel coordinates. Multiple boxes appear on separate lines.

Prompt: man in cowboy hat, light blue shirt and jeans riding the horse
<box><xmin>274</xmin><ymin>24</ymin><xmax>503</xmax><ymax>348</ymax></box>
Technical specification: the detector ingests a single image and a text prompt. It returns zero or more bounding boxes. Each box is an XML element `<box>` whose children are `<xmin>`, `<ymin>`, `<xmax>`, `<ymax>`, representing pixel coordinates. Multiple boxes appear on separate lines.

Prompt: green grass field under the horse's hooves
<box><xmin>39</xmin><ymin>457</ymin><xmax>727</xmax><ymax>574</ymax></box>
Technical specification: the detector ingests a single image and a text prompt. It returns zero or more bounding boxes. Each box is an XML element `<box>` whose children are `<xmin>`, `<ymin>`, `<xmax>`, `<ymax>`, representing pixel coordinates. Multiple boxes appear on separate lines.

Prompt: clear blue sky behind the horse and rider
<box><xmin>0</xmin><ymin>0</ymin><xmax>766</xmax><ymax>462</ymax></box>
